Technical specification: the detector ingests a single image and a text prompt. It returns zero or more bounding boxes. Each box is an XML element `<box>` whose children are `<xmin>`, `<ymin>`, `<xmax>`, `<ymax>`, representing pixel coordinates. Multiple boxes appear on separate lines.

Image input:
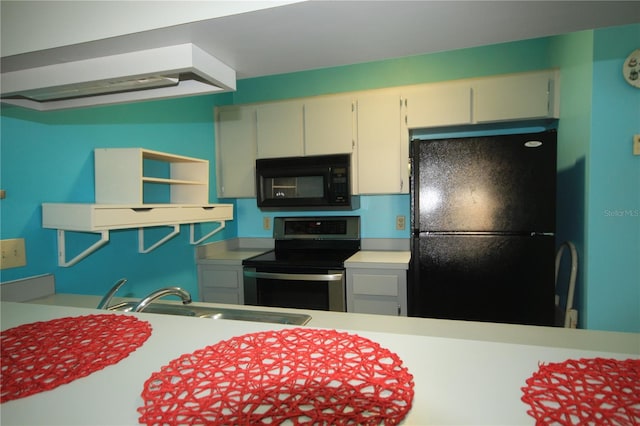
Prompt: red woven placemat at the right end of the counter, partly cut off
<box><xmin>522</xmin><ymin>358</ymin><xmax>640</xmax><ymax>425</ymax></box>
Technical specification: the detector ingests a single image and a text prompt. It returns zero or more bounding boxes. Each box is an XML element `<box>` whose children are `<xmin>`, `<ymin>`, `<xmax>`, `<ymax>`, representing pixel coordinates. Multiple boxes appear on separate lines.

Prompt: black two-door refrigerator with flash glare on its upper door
<box><xmin>407</xmin><ymin>130</ymin><xmax>557</xmax><ymax>325</ymax></box>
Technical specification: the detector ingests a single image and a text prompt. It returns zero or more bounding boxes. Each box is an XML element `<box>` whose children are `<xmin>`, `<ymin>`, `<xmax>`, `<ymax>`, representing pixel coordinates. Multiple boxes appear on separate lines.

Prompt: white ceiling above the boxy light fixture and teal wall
<box><xmin>2</xmin><ymin>0</ymin><xmax>640</xmax><ymax>79</ymax></box>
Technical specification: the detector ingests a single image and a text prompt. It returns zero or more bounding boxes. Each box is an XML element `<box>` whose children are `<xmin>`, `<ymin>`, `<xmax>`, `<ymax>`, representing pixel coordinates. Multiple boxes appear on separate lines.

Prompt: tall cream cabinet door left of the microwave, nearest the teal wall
<box><xmin>216</xmin><ymin>106</ymin><xmax>256</xmax><ymax>198</ymax></box>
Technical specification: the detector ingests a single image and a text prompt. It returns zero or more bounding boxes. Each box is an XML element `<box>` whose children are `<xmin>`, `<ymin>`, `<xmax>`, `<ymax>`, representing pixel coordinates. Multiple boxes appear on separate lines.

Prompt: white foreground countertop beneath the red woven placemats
<box><xmin>1</xmin><ymin>295</ymin><xmax>640</xmax><ymax>425</ymax></box>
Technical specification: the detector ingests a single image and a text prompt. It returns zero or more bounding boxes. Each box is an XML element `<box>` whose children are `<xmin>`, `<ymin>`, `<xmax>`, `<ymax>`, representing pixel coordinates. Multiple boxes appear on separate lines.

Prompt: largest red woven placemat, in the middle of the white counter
<box><xmin>138</xmin><ymin>328</ymin><xmax>413</xmax><ymax>425</ymax></box>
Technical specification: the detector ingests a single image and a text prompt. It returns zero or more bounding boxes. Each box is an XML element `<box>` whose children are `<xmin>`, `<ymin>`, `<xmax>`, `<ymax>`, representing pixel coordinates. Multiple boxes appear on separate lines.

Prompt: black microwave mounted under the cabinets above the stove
<box><xmin>256</xmin><ymin>154</ymin><xmax>359</xmax><ymax>210</ymax></box>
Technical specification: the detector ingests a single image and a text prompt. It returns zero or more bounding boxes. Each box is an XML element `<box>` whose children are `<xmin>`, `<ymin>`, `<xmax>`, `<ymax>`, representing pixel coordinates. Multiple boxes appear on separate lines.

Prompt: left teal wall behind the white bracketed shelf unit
<box><xmin>0</xmin><ymin>97</ymin><xmax>237</xmax><ymax>296</ymax></box>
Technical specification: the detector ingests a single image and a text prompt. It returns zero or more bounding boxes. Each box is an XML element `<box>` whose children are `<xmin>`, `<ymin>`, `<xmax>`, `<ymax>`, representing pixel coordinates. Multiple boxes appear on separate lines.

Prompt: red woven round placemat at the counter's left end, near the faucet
<box><xmin>0</xmin><ymin>314</ymin><xmax>151</xmax><ymax>402</ymax></box>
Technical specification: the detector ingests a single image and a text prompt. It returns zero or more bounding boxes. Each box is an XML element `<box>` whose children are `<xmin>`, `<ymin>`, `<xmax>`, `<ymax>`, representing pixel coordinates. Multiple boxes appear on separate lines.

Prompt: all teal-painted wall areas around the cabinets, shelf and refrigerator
<box><xmin>0</xmin><ymin>25</ymin><xmax>640</xmax><ymax>331</ymax></box>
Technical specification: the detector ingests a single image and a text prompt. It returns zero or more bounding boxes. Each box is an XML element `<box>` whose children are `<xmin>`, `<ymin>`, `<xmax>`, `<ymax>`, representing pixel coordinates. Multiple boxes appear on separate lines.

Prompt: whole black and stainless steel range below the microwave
<box><xmin>243</xmin><ymin>216</ymin><xmax>360</xmax><ymax>312</ymax></box>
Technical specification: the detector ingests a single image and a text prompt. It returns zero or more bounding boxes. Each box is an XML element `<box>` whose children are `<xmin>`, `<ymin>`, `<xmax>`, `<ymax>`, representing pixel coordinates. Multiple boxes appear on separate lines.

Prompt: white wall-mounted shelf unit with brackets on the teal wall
<box><xmin>42</xmin><ymin>148</ymin><xmax>233</xmax><ymax>266</ymax></box>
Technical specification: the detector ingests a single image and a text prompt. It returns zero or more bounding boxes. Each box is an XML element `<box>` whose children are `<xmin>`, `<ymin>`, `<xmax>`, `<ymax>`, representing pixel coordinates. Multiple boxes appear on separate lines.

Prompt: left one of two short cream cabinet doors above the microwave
<box><xmin>256</xmin><ymin>100</ymin><xmax>304</xmax><ymax>158</ymax></box>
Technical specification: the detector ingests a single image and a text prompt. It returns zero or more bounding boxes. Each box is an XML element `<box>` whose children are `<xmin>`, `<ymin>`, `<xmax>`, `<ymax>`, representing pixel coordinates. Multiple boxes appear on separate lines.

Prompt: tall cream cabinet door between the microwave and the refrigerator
<box><xmin>357</xmin><ymin>91</ymin><xmax>409</xmax><ymax>194</ymax></box>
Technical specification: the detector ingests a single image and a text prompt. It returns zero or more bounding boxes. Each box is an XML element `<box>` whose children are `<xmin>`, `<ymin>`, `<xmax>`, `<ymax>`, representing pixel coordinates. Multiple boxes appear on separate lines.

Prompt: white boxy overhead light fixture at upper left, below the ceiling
<box><xmin>0</xmin><ymin>43</ymin><xmax>236</xmax><ymax>111</ymax></box>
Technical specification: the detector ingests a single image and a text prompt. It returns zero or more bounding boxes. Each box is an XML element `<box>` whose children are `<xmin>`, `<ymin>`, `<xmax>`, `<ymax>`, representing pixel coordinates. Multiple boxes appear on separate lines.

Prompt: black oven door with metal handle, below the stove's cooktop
<box><xmin>244</xmin><ymin>267</ymin><xmax>346</xmax><ymax>312</ymax></box>
